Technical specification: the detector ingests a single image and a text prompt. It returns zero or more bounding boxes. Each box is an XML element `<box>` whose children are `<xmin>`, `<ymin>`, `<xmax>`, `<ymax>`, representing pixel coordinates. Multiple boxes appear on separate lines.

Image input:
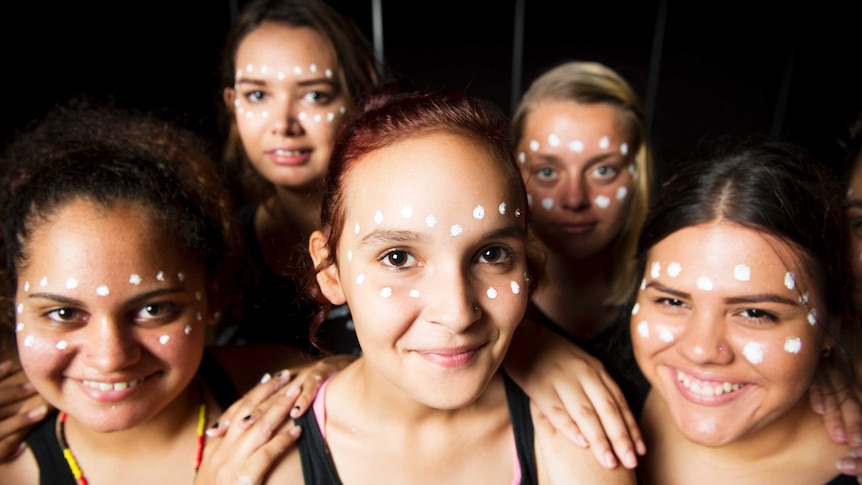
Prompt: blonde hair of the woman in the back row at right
<box><xmin>512</xmin><ymin>62</ymin><xmax>653</xmax><ymax>305</ymax></box>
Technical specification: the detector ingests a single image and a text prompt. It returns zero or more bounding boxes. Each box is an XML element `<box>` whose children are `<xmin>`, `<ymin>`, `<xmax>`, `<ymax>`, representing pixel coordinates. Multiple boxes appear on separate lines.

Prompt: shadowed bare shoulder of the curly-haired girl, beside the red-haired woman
<box><xmin>208</xmin><ymin>344</ymin><xmax>311</xmax><ymax>392</ymax></box>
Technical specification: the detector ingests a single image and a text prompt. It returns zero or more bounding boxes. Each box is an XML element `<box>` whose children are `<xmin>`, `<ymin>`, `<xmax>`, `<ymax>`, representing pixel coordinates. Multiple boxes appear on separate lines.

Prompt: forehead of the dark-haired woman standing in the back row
<box><xmin>236</xmin><ymin>22</ymin><xmax>337</xmax><ymax>76</ymax></box>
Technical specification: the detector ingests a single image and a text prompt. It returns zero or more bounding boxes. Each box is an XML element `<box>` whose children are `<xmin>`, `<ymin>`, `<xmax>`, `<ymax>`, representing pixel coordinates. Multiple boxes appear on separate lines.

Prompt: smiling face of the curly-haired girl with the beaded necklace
<box><xmin>16</xmin><ymin>201</ymin><xmax>207</xmax><ymax>431</ymax></box>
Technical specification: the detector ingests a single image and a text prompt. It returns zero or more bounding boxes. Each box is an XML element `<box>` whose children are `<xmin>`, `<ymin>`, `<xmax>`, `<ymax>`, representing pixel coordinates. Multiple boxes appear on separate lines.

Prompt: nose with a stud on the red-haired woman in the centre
<box><xmin>424</xmin><ymin>265</ymin><xmax>482</xmax><ymax>334</ymax></box>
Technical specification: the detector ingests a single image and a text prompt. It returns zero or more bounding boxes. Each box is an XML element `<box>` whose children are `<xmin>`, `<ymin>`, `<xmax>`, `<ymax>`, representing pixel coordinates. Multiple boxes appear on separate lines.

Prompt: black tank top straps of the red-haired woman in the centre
<box><xmin>296</xmin><ymin>372</ymin><xmax>539</xmax><ymax>485</ymax></box>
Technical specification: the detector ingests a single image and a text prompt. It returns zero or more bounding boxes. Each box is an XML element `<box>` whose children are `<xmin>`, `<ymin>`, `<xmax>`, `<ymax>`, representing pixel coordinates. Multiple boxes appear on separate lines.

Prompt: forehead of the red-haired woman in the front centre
<box><xmin>345</xmin><ymin>132</ymin><xmax>523</xmax><ymax>223</ymax></box>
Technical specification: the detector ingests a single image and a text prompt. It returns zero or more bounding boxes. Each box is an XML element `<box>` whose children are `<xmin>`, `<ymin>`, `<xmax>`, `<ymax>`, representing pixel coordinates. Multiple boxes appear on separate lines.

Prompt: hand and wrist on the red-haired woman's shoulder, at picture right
<box><xmin>504</xmin><ymin>320</ymin><xmax>646</xmax><ymax>469</ymax></box>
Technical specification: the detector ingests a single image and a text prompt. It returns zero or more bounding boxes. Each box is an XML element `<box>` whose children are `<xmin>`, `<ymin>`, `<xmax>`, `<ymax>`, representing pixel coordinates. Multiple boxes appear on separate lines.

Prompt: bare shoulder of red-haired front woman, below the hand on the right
<box><xmin>530</xmin><ymin>403</ymin><xmax>636</xmax><ymax>485</ymax></box>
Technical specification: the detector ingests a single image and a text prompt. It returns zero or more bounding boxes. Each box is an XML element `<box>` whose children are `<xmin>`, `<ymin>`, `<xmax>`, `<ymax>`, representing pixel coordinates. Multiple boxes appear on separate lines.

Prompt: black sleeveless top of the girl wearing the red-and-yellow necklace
<box><xmin>27</xmin><ymin>351</ymin><xmax>239</xmax><ymax>485</ymax></box>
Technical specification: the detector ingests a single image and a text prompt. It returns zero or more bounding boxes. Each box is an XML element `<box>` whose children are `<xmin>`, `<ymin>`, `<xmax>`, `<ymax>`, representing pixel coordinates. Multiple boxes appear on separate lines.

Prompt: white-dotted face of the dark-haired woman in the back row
<box><xmin>225</xmin><ymin>22</ymin><xmax>347</xmax><ymax>189</ymax></box>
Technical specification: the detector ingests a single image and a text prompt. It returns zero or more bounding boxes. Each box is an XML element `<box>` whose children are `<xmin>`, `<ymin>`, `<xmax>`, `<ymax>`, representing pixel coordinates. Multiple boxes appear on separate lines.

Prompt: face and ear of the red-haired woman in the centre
<box><xmin>313</xmin><ymin>133</ymin><xmax>528</xmax><ymax>409</ymax></box>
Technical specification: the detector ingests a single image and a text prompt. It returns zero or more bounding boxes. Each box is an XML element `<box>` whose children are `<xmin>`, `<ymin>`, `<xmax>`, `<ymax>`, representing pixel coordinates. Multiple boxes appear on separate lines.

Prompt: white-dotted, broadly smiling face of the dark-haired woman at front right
<box><xmin>631</xmin><ymin>222</ymin><xmax>823</xmax><ymax>446</ymax></box>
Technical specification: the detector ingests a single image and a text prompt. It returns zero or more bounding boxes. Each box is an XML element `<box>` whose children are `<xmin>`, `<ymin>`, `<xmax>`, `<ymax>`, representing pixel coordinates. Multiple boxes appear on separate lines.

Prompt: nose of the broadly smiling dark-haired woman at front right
<box><xmin>676</xmin><ymin>312</ymin><xmax>733</xmax><ymax>364</ymax></box>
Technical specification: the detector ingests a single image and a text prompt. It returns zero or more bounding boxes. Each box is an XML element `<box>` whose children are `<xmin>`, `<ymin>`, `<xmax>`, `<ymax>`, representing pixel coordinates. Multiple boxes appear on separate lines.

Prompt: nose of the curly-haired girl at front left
<box><xmin>81</xmin><ymin>316</ymin><xmax>141</xmax><ymax>372</ymax></box>
